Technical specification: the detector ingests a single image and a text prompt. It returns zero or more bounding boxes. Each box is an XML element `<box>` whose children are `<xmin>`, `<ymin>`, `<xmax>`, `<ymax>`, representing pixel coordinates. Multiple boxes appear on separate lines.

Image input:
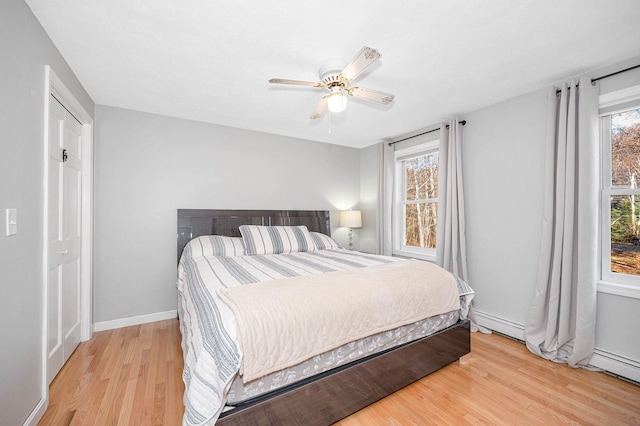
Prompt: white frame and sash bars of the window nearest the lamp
<box><xmin>392</xmin><ymin>139</ymin><xmax>440</xmax><ymax>262</ymax></box>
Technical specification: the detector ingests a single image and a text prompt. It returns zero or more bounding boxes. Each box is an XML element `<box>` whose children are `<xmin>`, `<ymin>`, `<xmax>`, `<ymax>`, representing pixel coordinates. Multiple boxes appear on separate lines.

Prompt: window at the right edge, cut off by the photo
<box><xmin>601</xmin><ymin>92</ymin><xmax>640</xmax><ymax>297</ymax></box>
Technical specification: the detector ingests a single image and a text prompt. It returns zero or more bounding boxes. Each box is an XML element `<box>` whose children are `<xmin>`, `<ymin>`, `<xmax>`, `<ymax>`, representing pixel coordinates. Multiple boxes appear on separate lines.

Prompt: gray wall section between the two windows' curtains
<box><xmin>462</xmin><ymin>89</ymin><xmax>547</xmax><ymax>324</ymax></box>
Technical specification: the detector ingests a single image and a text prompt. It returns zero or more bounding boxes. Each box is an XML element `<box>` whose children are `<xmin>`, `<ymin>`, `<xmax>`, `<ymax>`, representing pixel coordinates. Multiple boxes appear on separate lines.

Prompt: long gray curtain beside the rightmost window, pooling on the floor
<box><xmin>525</xmin><ymin>78</ymin><xmax>600</xmax><ymax>367</ymax></box>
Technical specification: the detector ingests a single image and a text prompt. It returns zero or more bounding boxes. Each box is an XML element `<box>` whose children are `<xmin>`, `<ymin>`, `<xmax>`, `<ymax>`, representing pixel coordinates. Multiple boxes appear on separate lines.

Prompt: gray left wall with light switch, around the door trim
<box><xmin>0</xmin><ymin>0</ymin><xmax>93</xmax><ymax>425</ymax></box>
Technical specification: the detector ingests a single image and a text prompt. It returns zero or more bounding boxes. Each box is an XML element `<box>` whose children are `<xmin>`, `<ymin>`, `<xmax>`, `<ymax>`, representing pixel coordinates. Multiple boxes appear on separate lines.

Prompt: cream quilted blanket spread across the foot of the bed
<box><xmin>217</xmin><ymin>260</ymin><xmax>460</xmax><ymax>383</ymax></box>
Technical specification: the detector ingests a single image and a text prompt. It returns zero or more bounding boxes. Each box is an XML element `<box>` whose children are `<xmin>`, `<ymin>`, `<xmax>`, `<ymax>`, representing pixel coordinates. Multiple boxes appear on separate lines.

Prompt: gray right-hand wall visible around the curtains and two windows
<box><xmin>360</xmin><ymin>58</ymin><xmax>640</xmax><ymax>377</ymax></box>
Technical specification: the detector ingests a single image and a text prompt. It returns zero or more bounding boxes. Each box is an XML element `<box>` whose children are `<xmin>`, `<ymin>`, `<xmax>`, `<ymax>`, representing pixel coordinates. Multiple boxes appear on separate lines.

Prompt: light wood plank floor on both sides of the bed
<box><xmin>40</xmin><ymin>320</ymin><xmax>640</xmax><ymax>426</ymax></box>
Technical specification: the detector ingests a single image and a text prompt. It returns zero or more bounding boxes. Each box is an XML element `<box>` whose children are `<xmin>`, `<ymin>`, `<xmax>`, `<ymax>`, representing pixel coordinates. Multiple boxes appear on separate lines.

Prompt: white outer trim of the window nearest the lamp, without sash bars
<box><xmin>392</xmin><ymin>139</ymin><xmax>440</xmax><ymax>262</ymax></box>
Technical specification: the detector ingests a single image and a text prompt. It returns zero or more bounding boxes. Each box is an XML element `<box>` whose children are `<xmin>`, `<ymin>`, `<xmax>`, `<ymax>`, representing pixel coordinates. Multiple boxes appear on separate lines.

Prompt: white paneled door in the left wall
<box><xmin>47</xmin><ymin>96</ymin><xmax>82</xmax><ymax>383</ymax></box>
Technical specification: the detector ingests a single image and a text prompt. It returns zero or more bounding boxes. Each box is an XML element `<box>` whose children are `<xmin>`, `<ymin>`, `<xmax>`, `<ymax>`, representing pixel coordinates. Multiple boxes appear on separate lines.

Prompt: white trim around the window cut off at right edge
<box><xmin>597</xmin><ymin>85</ymin><xmax>640</xmax><ymax>299</ymax></box>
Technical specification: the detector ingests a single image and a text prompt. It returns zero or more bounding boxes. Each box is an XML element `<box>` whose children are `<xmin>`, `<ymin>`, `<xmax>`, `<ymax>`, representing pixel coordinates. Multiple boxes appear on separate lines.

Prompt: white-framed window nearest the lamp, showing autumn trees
<box><xmin>393</xmin><ymin>140</ymin><xmax>439</xmax><ymax>261</ymax></box>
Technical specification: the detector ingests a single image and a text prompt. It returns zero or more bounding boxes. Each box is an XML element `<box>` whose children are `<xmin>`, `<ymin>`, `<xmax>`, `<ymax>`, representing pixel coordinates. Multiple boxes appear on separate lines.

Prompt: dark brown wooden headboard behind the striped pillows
<box><xmin>178</xmin><ymin>209</ymin><xmax>331</xmax><ymax>262</ymax></box>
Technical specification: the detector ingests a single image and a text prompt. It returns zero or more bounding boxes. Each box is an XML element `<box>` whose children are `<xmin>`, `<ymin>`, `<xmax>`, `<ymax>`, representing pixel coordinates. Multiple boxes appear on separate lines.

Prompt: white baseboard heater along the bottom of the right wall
<box><xmin>473</xmin><ymin>310</ymin><xmax>640</xmax><ymax>382</ymax></box>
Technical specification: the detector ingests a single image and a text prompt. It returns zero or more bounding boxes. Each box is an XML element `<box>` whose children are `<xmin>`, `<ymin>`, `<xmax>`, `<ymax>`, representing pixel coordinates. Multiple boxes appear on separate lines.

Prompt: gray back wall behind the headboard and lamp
<box><xmin>93</xmin><ymin>106</ymin><xmax>360</xmax><ymax>323</ymax></box>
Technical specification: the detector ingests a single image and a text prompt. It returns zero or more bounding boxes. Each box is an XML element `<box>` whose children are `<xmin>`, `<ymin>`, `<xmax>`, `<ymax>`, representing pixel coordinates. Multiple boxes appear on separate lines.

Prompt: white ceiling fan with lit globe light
<box><xmin>269</xmin><ymin>46</ymin><xmax>394</xmax><ymax>119</ymax></box>
